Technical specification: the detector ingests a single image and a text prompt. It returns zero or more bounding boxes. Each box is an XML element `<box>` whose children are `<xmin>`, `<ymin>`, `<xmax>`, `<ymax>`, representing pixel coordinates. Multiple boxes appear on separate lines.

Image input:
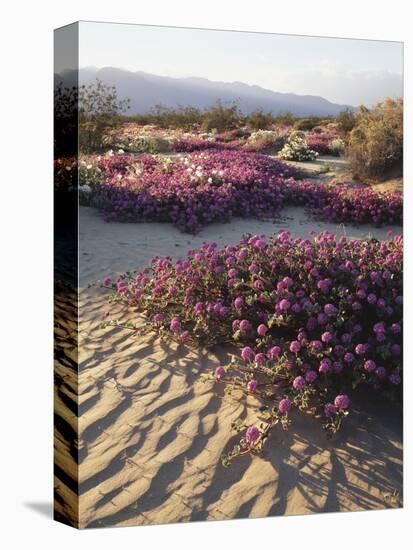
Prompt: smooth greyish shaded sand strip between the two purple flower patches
<box><xmin>79</xmin><ymin>206</ymin><xmax>401</xmax><ymax>286</ymax></box>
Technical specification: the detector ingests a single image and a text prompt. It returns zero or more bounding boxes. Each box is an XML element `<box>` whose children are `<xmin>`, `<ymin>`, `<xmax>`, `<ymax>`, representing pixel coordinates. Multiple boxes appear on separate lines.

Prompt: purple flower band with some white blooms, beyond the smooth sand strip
<box><xmin>69</xmin><ymin>150</ymin><xmax>403</xmax><ymax>233</ymax></box>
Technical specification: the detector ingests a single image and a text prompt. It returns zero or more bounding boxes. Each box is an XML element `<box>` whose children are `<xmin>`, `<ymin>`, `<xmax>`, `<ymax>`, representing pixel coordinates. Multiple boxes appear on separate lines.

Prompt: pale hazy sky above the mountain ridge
<box><xmin>79</xmin><ymin>22</ymin><xmax>403</xmax><ymax>106</ymax></box>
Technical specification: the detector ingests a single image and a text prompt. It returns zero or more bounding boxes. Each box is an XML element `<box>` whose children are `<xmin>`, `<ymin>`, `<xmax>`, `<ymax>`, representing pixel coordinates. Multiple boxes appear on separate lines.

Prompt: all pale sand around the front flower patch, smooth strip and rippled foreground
<box><xmin>56</xmin><ymin>208</ymin><xmax>402</xmax><ymax>527</ymax></box>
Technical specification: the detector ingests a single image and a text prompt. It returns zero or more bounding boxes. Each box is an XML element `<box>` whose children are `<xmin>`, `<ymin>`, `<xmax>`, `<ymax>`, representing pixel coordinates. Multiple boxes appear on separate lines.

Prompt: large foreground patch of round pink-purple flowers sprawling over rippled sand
<box><xmin>102</xmin><ymin>231</ymin><xmax>403</xmax><ymax>465</ymax></box>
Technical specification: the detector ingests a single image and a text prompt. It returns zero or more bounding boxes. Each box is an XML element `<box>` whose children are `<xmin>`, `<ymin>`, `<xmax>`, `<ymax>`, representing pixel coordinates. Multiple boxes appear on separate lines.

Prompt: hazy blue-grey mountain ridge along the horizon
<box><xmin>55</xmin><ymin>67</ymin><xmax>353</xmax><ymax>117</ymax></box>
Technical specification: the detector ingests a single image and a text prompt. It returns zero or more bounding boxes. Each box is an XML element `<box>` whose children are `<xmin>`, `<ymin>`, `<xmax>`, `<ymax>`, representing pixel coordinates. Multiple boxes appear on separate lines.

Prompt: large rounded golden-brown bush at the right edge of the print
<box><xmin>347</xmin><ymin>99</ymin><xmax>403</xmax><ymax>179</ymax></box>
